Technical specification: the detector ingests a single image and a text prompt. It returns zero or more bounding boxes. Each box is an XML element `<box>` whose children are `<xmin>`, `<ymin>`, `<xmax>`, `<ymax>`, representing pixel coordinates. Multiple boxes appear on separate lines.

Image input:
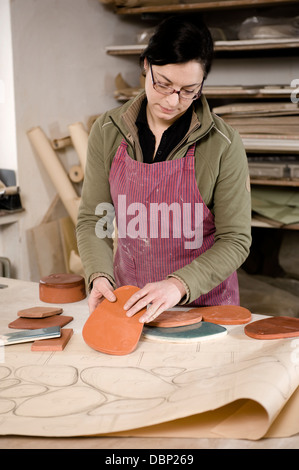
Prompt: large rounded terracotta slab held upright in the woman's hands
<box><xmin>82</xmin><ymin>286</ymin><xmax>146</xmax><ymax>356</ymax></box>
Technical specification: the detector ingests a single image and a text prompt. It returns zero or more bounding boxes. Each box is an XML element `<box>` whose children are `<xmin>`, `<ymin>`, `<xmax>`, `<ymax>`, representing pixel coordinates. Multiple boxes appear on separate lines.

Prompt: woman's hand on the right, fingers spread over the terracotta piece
<box><xmin>124</xmin><ymin>278</ymin><xmax>186</xmax><ymax>323</ymax></box>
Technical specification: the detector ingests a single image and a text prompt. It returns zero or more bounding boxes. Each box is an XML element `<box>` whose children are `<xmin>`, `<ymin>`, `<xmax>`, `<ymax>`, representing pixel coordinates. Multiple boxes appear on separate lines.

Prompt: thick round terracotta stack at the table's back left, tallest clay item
<box><xmin>39</xmin><ymin>273</ymin><xmax>86</xmax><ymax>304</ymax></box>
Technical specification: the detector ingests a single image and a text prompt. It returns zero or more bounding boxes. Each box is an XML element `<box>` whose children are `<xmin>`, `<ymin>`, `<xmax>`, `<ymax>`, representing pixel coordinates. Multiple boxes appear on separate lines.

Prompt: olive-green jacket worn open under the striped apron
<box><xmin>76</xmin><ymin>92</ymin><xmax>251</xmax><ymax>303</ymax></box>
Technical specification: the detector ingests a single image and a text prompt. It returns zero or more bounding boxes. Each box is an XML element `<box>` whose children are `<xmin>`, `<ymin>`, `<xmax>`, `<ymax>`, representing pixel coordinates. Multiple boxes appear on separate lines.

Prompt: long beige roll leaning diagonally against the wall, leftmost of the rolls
<box><xmin>27</xmin><ymin>126</ymin><xmax>79</xmax><ymax>224</ymax></box>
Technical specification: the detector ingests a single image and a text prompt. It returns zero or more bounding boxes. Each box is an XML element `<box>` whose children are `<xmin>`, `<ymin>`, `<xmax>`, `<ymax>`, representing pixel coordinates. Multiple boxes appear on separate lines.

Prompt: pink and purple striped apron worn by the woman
<box><xmin>109</xmin><ymin>140</ymin><xmax>239</xmax><ymax>306</ymax></box>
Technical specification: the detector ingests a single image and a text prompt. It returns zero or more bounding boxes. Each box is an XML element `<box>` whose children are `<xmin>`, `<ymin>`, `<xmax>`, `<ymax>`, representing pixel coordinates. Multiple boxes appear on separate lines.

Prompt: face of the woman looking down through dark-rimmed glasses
<box><xmin>144</xmin><ymin>59</ymin><xmax>204</xmax><ymax>125</ymax></box>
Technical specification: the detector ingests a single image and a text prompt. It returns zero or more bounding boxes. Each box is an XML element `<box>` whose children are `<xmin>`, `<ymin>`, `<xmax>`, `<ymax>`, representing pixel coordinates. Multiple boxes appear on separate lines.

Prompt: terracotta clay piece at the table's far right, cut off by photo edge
<box><xmin>244</xmin><ymin>317</ymin><xmax>299</xmax><ymax>339</ymax></box>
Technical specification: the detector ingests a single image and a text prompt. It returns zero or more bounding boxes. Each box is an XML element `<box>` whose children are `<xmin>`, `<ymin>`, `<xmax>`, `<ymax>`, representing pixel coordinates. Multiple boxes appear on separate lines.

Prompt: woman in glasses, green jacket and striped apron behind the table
<box><xmin>77</xmin><ymin>16</ymin><xmax>251</xmax><ymax>322</ymax></box>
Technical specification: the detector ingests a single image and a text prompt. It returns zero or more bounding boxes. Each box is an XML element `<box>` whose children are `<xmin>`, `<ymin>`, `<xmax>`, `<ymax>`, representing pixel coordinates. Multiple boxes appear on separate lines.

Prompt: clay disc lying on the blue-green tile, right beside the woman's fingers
<box><xmin>147</xmin><ymin>308</ymin><xmax>202</xmax><ymax>328</ymax></box>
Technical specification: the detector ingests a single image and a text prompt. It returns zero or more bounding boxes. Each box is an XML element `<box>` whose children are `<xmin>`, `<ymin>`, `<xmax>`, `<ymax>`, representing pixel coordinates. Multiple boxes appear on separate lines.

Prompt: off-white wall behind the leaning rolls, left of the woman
<box><xmin>7</xmin><ymin>0</ymin><xmax>139</xmax><ymax>280</ymax></box>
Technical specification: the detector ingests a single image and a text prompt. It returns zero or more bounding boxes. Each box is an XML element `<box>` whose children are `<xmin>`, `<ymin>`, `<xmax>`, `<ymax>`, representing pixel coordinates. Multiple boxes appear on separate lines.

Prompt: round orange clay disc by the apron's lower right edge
<box><xmin>200</xmin><ymin>305</ymin><xmax>251</xmax><ymax>325</ymax></box>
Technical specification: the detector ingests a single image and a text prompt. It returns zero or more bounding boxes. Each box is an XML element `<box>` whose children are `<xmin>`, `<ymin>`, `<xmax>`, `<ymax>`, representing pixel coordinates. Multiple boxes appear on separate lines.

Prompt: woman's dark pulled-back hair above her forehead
<box><xmin>140</xmin><ymin>15</ymin><xmax>213</xmax><ymax>78</ymax></box>
